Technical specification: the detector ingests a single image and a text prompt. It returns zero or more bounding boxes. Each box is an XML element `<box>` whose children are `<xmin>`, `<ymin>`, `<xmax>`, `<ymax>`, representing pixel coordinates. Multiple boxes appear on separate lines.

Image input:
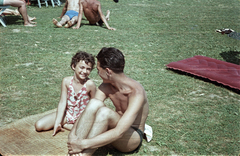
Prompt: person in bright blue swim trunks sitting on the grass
<box><xmin>53</xmin><ymin>0</ymin><xmax>79</xmax><ymax>28</ymax></box>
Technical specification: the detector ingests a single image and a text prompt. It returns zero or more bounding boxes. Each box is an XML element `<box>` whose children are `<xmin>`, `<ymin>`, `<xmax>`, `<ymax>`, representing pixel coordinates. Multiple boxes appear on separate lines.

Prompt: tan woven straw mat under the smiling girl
<box><xmin>0</xmin><ymin>110</ymin><xmax>69</xmax><ymax>155</ymax></box>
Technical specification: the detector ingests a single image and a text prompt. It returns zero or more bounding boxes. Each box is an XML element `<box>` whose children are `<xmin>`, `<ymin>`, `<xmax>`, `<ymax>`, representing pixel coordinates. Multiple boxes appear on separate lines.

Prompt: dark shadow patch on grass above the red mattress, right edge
<box><xmin>220</xmin><ymin>50</ymin><xmax>240</xmax><ymax>65</ymax></box>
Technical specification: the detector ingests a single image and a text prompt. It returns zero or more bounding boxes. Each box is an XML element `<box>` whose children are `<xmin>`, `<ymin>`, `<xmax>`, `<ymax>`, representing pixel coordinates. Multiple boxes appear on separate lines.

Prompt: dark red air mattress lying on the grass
<box><xmin>167</xmin><ymin>56</ymin><xmax>240</xmax><ymax>90</ymax></box>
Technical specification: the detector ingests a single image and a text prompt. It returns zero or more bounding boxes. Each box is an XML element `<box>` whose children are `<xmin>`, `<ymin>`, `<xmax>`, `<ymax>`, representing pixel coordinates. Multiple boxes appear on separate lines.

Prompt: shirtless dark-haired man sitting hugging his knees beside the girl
<box><xmin>68</xmin><ymin>48</ymin><xmax>149</xmax><ymax>155</ymax></box>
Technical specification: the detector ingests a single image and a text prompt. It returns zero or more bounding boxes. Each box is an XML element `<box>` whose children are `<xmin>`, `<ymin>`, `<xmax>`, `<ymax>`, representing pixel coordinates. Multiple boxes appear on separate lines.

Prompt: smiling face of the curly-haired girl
<box><xmin>72</xmin><ymin>60</ymin><xmax>92</xmax><ymax>80</ymax></box>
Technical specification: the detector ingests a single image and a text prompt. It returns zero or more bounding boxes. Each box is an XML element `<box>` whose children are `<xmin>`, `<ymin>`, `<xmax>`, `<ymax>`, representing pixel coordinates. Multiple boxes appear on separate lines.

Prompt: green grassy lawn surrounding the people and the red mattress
<box><xmin>0</xmin><ymin>0</ymin><xmax>240</xmax><ymax>155</ymax></box>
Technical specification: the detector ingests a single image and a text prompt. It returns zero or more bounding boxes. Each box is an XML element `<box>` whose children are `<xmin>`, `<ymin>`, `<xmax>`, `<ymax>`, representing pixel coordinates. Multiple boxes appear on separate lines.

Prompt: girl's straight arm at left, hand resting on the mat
<box><xmin>53</xmin><ymin>77</ymin><xmax>70</xmax><ymax>136</ymax></box>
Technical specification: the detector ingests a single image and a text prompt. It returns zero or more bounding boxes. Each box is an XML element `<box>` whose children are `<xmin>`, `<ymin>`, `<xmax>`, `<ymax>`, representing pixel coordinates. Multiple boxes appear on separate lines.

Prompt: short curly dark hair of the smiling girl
<box><xmin>70</xmin><ymin>51</ymin><xmax>95</xmax><ymax>69</ymax></box>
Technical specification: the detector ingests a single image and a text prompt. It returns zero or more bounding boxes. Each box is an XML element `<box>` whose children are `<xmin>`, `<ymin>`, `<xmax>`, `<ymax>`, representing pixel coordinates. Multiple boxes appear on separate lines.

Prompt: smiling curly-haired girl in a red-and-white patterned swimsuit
<box><xmin>35</xmin><ymin>51</ymin><xmax>96</xmax><ymax>136</ymax></box>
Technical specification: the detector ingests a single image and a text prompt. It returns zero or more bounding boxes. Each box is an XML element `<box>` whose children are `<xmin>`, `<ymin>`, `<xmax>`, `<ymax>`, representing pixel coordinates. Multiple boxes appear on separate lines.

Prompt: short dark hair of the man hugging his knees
<box><xmin>97</xmin><ymin>47</ymin><xmax>125</xmax><ymax>73</ymax></box>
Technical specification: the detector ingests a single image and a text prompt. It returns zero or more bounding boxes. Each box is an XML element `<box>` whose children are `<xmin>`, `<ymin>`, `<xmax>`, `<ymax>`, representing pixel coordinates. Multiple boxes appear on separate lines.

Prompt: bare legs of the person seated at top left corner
<box><xmin>0</xmin><ymin>0</ymin><xmax>36</xmax><ymax>27</ymax></box>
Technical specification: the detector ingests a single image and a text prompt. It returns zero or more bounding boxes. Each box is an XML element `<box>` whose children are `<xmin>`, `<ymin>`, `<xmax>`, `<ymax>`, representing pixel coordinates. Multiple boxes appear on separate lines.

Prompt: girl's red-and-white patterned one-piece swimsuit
<box><xmin>66</xmin><ymin>78</ymin><xmax>90</xmax><ymax>124</ymax></box>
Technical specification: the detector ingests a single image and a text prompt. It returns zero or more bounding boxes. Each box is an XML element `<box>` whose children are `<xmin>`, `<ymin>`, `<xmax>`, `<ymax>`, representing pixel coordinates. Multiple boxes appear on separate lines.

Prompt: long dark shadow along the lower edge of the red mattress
<box><xmin>167</xmin><ymin>68</ymin><xmax>240</xmax><ymax>94</ymax></box>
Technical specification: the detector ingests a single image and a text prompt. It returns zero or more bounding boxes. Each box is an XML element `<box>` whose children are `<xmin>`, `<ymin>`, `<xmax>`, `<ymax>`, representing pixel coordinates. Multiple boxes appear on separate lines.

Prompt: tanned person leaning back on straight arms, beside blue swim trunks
<box><xmin>73</xmin><ymin>0</ymin><xmax>116</xmax><ymax>30</ymax></box>
